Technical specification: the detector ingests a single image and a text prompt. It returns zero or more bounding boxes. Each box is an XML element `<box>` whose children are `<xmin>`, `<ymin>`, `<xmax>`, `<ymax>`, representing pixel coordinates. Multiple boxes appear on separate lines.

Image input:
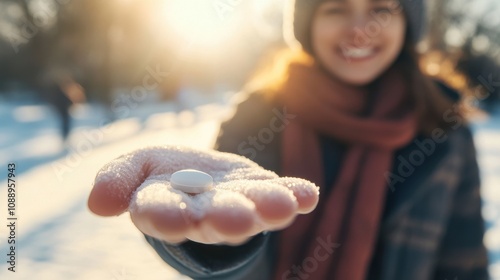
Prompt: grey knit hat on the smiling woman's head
<box><xmin>284</xmin><ymin>0</ymin><xmax>426</xmax><ymax>53</ymax></box>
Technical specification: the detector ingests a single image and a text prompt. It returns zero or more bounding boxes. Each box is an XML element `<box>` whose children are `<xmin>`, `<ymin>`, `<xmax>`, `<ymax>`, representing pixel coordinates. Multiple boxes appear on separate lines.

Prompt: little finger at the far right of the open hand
<box><xmin>271</xmin><ymin>177</ymin><xmax>319</xmax><ymax>214</ymax></box>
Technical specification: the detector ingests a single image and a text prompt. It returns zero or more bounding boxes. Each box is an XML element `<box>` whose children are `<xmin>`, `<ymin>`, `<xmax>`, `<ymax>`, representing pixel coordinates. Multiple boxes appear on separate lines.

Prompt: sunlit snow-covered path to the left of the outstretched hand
<box><xmin>0</xmin><ymin>99</ymin><xmax>226</xmax><ymax>280</ymax></box>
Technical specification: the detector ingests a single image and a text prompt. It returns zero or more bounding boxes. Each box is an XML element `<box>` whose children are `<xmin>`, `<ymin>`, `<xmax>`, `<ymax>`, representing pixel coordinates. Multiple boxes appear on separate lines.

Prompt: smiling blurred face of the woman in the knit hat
<box><xmin>311</xmin><ymin>0</ymin><xmax>406</xmax><ymax>86</ymax></box>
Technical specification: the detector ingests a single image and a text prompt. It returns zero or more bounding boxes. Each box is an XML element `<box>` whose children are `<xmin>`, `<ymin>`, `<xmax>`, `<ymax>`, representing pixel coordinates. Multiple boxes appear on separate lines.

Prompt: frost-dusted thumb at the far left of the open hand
<box><xmin>87</xmin><ymin>150</ymin><xmax>150</xmax><ymax>216</ymax></box>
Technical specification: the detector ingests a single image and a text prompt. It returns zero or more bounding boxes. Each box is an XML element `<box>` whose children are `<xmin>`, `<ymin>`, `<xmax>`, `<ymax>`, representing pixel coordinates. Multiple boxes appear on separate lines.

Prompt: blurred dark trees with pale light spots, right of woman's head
<box><xmin>422</xmin><ymin>0</ymin><xmax>500</xmax><ymax>110</ymax></box>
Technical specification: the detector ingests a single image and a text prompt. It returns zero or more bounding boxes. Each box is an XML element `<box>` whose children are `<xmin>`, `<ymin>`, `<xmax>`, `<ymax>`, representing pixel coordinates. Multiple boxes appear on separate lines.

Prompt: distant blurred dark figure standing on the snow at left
<box><xmin>42</xmin><ymin>71</ymin><xmax>86</xmax><ymax>141</ymax></box>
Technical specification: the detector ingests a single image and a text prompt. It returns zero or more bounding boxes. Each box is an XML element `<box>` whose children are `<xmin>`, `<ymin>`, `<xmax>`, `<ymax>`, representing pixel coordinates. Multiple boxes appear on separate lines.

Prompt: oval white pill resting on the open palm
<box><xmin>170</xmin><ymin>169</ymin><xmax>214</xmax><ymax>193</ymax></box>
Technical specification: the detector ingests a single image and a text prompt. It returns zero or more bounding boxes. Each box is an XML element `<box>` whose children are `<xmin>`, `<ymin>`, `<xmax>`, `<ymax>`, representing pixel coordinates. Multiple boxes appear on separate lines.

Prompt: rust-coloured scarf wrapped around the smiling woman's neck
<box><xmin>275</xmin><ymin>64</ymin><xmax>417</xmax><ymax>280</ymax></box>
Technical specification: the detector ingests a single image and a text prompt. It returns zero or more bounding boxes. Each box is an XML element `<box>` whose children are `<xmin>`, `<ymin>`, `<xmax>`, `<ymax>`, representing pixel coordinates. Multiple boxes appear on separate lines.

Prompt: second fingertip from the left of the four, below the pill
<box><xmin>201</xmin><ymin>190</ymin><xmax>257</xmax><ymax>243</ymax></box>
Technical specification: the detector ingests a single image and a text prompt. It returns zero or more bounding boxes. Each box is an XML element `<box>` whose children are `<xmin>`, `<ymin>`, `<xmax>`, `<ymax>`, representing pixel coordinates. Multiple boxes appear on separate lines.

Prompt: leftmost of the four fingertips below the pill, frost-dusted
<box><xmin>129</xmin><ymin>181</ymin><xmax>196</xmax><ymax>243</ymax></box>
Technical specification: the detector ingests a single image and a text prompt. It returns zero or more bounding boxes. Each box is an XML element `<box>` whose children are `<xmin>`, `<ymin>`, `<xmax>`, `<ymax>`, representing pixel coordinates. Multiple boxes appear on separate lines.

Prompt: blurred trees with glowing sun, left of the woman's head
<box><xmin>0</xmin><ymin>0</ymin><xmax>286</xmax><ymax>103</ymax></box>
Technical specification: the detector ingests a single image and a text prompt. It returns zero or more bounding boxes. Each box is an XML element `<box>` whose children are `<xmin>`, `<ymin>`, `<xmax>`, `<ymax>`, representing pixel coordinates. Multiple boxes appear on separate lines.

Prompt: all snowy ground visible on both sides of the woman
<box><xmin>0</xmin><ymin>95</ymin><xmax>500</xmax><ymax>280</ymax></box>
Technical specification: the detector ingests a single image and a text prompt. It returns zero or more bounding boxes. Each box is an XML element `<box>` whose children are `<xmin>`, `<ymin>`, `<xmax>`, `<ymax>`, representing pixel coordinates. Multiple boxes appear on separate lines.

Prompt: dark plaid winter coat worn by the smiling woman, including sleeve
<box><xmin>146</xmin><ymin>87</ymin><xmax>488</xmax><ymax>280</ymax></box>
